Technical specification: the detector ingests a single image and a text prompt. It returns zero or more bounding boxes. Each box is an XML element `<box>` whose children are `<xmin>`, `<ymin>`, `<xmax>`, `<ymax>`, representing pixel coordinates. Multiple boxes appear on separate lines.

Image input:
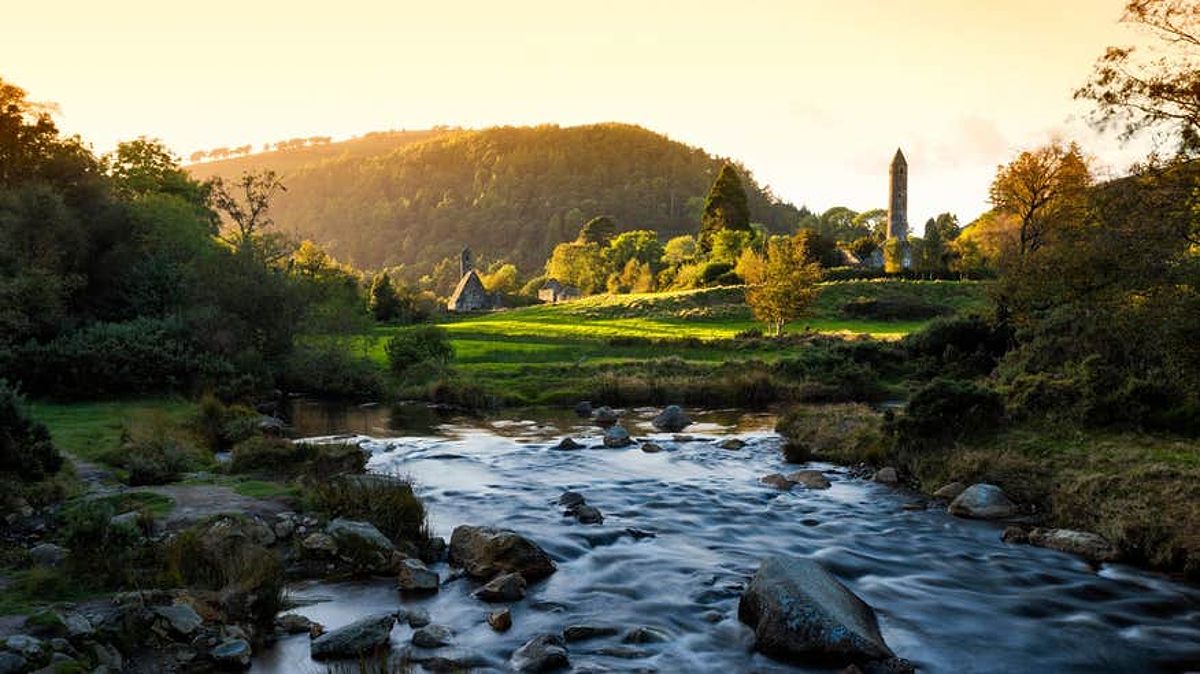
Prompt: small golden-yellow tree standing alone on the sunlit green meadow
<box><xmin>738</xmin><ymin>237</ymin><xmax>821</xmax><ymax>336</ymax></box>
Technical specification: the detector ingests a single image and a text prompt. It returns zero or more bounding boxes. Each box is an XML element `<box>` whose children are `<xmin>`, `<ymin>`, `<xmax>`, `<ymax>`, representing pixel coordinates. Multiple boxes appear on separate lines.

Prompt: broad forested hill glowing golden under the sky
<box><xmin>191</xmin><ymin>124</ymin><xmax>800</xmax><ymax>271</ymax></box>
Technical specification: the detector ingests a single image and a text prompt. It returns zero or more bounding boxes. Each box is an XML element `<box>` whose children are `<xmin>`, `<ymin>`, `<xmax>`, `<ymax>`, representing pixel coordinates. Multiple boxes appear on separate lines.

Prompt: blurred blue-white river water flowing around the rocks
<box><xmin>254</xmin><ymin>405</ymin><xmax>1200</xmax><ymax>674</ymax></box>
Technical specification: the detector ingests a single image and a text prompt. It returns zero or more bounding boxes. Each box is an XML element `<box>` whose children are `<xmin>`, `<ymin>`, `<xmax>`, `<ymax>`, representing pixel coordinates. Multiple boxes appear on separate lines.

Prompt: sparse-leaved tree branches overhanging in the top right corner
<box><xmin>1075</xmin><ymin>0</ymin><xmax>1200</xmax><ymax>156</ymax></box>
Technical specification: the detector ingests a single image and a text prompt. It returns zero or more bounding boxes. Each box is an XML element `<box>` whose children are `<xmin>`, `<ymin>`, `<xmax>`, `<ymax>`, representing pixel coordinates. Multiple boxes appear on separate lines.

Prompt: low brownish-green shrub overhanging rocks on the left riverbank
<box><xmin>308</xmin><ymin>475</ymin><xmax>430</xmax><ymax>549</ymax></box>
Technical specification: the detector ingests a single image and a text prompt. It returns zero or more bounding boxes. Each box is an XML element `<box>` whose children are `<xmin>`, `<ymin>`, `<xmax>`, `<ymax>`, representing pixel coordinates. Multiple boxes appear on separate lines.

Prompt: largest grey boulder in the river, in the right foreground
<box><xmin>738</xmin><ymin>556</ymin><xmax>894</xmax><ymax>666</ymax></box>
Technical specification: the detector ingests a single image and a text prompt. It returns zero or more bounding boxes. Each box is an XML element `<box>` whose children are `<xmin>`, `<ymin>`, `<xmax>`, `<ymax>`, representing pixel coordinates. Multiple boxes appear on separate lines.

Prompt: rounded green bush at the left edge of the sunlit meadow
<box><xmin>280</xmin><ymin>342</ymin><xmax>391</xmax><ymax>401</ymax></box>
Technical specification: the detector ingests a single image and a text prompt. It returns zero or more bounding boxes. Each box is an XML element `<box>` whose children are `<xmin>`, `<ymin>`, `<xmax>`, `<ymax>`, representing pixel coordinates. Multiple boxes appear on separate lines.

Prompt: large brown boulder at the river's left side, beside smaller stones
<box><xmin>450</xmin><ymin>524</ymin><xmax>554</xmax><ymax>583</ymax></box>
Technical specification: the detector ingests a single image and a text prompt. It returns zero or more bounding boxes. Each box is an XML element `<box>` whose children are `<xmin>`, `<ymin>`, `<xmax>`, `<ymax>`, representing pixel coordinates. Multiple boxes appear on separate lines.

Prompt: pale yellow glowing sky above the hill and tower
<box><xmin>0</xmin><ymin>0</ymin><xmax>1161</xmax><ymax>231</ymax></box>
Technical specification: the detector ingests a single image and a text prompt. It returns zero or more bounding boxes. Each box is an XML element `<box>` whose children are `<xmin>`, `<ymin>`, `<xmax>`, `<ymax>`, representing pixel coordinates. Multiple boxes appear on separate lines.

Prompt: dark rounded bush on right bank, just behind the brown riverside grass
<box><xmin>895</xmin><ymin>379</ymin><xmax>1004</xmax><ymax>450</ymax></box>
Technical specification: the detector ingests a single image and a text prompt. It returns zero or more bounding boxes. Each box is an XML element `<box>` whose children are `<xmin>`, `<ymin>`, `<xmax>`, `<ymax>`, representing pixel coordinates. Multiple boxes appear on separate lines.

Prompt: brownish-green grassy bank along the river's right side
<box><xmin>779</xmin><ymin>405</ymin><xmax>1200</xmax><ymax>578</ymax></box>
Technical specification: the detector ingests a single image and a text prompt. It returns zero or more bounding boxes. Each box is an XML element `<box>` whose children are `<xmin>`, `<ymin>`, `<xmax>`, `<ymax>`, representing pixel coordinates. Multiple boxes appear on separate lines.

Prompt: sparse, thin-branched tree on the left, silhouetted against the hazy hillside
<box><xmin>211</xmin><ymin>170</ymin><xmax>290</xmax><ymax>264</ymax></box>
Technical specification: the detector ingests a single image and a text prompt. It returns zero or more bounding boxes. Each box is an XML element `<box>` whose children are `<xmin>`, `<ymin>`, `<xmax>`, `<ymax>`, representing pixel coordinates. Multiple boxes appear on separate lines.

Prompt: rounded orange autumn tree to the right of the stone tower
<box><xmin>991</xmin><ymin>142</ymin><xmax>1091</xmax><ymax>259</ymax></box>
